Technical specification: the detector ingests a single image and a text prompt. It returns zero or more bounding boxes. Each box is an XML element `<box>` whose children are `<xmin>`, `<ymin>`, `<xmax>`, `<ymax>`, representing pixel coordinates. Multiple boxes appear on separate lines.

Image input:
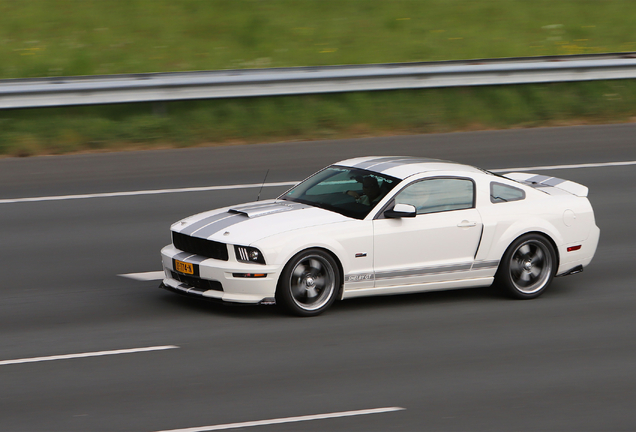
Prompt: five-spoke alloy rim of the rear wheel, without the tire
<box><xmin>510</xmin><ymin>239</ymin><xmax>554</xmax><ymax>294</ymax></box>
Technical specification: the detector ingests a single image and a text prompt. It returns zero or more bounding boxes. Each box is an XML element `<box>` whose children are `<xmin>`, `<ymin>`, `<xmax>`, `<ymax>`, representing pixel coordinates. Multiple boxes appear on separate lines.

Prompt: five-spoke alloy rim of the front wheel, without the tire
<box><xmin>289</xmin><ymin>255</ymin><xmax>336</xmax><ymax>311</ymax></box>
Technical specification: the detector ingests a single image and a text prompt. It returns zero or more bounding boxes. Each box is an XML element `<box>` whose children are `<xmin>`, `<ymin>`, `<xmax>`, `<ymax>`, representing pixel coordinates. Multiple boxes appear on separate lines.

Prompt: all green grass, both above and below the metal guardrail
<box><xmin>0</xmin><ymin>0</ymin><xmax>636</xmax><ymax>156</ymax></box>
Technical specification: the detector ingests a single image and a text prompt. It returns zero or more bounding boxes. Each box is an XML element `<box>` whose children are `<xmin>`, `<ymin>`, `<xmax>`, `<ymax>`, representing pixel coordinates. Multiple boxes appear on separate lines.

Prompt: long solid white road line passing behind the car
<box><xmin>0</xmin><ymin>161</ymin><xmax>636</xmax><ymax>204</ymax></box>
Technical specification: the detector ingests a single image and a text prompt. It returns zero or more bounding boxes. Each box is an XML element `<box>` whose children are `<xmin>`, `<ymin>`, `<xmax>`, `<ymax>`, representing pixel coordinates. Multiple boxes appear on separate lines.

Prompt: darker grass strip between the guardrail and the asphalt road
<box><xmin>0</xmin><ymin>80</ymin><xmax>636</xmax><ymax>156</ymax></box>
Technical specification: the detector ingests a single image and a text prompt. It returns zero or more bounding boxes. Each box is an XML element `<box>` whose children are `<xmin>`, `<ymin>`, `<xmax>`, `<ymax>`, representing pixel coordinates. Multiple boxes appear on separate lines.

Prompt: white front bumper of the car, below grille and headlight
<box><xmin>160</xmin><ymin>245</ymin><xmax>281</xmax><ymax>304</ymax></box>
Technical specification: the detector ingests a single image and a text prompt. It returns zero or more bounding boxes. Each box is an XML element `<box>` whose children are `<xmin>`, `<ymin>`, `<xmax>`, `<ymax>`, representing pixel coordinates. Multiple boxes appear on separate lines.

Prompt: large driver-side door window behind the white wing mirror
<box><xmin>395</xmin><ymin>178</ymin><xmax>475</xmax><ymax>214</ymax></box>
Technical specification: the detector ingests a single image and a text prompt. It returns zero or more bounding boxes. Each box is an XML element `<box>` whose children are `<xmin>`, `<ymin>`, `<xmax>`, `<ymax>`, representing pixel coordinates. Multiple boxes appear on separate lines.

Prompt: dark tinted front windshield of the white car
<box><xmin>279</xmin><ymin>165</ymin><xmax>400</xmax><ymax>219</ymax></box>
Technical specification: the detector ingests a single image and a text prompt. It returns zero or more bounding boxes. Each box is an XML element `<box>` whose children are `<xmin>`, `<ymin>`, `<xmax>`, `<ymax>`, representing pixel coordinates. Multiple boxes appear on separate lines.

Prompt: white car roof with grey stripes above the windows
<box><xmin>335</xmin><ymin>156</ymin><xmax>483</xmax><ymax>179</ymax></box>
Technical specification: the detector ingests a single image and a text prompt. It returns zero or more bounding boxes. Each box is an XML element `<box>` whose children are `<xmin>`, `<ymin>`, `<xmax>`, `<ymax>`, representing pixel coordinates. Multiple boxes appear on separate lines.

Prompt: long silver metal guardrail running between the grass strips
<box><xmin>0</xmin><ymin>52</ymin><xmax>636</xmax><ymax>109</ymax></box>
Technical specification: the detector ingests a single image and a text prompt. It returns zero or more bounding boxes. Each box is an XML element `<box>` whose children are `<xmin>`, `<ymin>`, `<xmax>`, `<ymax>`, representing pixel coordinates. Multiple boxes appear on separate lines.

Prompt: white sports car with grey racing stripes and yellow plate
<box><xmin>161</xmin><ymin>157</ymin><xmax>600</xmax><ymax>316</ymax></box>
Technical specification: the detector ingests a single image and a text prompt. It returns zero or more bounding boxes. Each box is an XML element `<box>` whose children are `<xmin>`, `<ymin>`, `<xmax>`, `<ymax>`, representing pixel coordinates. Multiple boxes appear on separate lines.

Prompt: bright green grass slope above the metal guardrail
<box><xmin>0</xmin><ymin>0</ymin><xmax>636</xmax><ymax>78</ymax></box>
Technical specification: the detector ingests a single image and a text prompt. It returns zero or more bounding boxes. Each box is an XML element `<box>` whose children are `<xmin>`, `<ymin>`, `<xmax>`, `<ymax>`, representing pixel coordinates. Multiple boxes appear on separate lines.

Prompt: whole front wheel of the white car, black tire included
<box><xmin>276</xmin><ymin>249</ymin><xmax>340</xmax><ymax>316</ymax></box>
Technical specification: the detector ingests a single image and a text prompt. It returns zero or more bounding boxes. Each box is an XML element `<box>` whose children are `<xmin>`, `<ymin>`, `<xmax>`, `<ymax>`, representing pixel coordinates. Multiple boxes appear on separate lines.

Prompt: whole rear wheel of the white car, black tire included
<box><xmin>495</xmin><ymin>234</ymin><xmax>557</xmax><ymax>299</ymax></box>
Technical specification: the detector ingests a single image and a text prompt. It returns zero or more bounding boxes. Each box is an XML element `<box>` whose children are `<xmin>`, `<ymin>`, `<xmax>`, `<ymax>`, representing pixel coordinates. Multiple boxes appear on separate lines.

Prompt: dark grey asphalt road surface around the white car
<box><xmin>0</xmin><ymin>124</ymin><xmax>636</xmax><ymax>431</ymax></box>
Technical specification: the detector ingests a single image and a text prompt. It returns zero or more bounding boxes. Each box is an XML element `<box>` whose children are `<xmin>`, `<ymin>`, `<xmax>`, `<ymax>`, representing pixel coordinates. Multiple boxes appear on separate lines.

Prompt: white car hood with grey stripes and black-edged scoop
<box><xmin>171</xmin><ymin>200</ymin><xmax>351</xmax><ymax>246</ymax></box>
